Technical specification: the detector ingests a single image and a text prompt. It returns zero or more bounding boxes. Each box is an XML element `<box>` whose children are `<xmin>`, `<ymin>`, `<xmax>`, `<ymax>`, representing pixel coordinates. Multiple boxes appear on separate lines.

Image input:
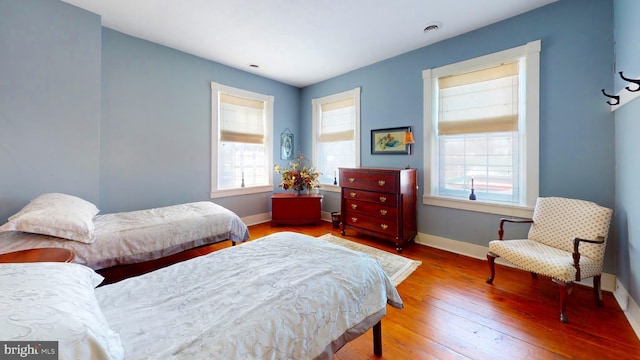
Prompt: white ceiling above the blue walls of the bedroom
<box><xmin>63</xmin><ymin>0</ymin><xmax>556</xmax><ymax>87</ymax></box>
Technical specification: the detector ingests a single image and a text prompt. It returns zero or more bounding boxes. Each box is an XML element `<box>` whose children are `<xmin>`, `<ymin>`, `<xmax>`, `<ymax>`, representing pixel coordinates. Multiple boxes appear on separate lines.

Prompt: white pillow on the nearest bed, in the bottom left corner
<box><xmin>0</xmin><ymin>262</ymin><xmax>124</xmax><ymax>359</ymax></box>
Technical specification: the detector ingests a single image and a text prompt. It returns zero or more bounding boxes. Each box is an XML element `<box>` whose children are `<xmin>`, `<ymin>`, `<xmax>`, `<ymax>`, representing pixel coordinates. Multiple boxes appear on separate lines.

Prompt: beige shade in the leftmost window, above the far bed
<box><xmin>220</xmin><ymin>94</ymin><xmax>265</xmax><ymax>144</ymax></box>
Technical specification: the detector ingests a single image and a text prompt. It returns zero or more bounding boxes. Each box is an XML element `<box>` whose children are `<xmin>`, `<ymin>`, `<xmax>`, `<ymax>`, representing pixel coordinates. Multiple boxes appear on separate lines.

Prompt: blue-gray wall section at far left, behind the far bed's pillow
<box><xmin>0</xmin><ymin>0</ymin><xmax>101</xmax><ymax>219</ymax></box>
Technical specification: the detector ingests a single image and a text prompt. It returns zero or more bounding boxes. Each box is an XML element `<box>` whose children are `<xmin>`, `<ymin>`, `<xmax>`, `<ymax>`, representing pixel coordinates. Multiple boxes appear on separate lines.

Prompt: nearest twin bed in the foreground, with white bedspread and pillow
<box><xmin>0</xmin><ymin>194</ymin><xmax>402</xmax><ymax>359</ymax></box>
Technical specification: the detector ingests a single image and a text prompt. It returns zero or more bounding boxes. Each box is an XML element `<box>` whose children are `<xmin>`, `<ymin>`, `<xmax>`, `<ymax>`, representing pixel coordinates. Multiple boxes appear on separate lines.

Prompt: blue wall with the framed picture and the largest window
<box><xmin>301</xmin><ymin>0</ymin><xmax>616</xmax><ymax>273</ymax></box>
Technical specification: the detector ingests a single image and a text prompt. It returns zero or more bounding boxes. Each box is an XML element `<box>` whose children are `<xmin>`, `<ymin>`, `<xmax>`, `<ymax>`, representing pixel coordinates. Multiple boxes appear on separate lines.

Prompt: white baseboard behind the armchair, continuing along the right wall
<box><xmin>415</xmin><ymin>233</ymin><xmax>640</xmax><ymax>339</ymax></box>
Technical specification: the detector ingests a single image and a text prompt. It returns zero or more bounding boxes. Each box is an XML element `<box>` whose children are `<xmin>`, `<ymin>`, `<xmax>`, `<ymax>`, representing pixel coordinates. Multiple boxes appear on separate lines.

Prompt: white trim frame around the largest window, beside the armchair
<box><xmin>422</xmin><ymin>40</ymin><xmax>541</xmax><ymax>218</ymax></box>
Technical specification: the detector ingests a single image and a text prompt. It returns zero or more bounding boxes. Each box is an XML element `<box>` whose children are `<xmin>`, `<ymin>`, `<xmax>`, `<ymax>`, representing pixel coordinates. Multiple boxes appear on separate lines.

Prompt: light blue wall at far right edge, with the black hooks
<box><xmin>607</xmin><ymin>0</ymin><xmax>640</xmax><ymax>310</ymax></box>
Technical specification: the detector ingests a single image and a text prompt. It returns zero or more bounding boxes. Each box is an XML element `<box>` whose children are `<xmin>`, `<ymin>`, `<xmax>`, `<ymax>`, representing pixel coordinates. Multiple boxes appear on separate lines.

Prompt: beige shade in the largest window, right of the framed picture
<box><xmin>438</xmin><ymin>62</ymin><xmax>519</xmax><ymax>135</ymax></box>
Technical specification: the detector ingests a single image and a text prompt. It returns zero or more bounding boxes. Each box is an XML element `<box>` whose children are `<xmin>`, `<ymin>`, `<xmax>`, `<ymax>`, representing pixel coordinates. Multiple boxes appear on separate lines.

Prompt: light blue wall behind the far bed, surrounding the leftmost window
<box><xmin>100</xmin><ymin>28</ymin><xmax>300</xmax><ymax>216</ymax></box>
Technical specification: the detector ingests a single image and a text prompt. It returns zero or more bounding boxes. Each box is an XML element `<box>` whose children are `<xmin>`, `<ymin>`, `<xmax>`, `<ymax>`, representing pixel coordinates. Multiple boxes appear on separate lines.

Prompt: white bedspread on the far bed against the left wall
<box><xmin>0</xmin><ymin>201</ymin><xmax>249</xmax><ymax>269</ymax></box>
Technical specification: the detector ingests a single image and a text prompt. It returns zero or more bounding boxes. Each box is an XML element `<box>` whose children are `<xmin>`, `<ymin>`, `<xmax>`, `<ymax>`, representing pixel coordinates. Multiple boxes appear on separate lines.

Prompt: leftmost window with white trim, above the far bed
<box><xmin>211</xmin><ymin>82</ymin><xmax>273</xmax><ymax>198</ymax></box>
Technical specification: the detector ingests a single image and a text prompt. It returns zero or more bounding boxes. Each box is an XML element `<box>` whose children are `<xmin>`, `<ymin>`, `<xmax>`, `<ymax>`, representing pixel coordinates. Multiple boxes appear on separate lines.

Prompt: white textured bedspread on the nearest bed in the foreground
<box><xmin>96</xmin><ymin>232</ymin><xmax>402</xmax><ymax>360</ymax></box>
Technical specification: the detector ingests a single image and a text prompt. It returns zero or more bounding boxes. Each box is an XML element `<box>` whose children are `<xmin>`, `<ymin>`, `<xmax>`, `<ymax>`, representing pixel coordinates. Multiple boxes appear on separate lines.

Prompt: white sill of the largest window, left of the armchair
<box><xmin>422</xmin><ymin>195</ymin><xmax>533</xmax><ymax>219</ymax></box>
